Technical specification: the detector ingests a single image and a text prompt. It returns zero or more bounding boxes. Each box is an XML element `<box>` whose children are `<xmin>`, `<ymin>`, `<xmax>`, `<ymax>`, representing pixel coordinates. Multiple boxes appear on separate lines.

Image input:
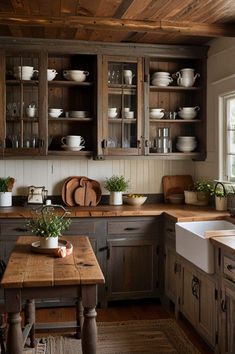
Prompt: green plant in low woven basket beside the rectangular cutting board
<box><xmin>184</xmin><ymin>179</ymin><xmax>213</xmax><ymax>206</ymax></box>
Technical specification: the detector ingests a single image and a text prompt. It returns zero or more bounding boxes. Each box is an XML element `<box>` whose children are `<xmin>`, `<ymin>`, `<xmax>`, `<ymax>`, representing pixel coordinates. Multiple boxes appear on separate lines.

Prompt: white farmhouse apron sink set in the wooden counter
<box><xmin>175</xmin><ymin>220</ymin><xmax>235</xmax><ymax>274</ymax></box>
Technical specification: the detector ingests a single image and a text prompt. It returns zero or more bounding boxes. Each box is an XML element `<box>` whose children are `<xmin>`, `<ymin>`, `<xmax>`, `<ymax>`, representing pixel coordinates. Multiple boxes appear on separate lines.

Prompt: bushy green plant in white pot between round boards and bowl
<box><xmin>104</xmin><ymin>175</ymin><xmax>129</xmax><ymax>205</ymax></box>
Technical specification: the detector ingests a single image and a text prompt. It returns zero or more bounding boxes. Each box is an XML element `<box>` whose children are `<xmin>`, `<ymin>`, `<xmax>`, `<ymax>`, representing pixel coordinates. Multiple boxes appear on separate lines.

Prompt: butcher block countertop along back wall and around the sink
<box><xmin>0</xmin><ymin>204</ymin><xmax>235</xmax><ymax>254</ymax></box>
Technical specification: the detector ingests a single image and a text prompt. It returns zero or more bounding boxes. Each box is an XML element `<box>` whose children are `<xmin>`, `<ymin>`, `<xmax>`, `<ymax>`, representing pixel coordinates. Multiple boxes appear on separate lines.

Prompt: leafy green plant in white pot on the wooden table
<box><xmin>27</xmin><ymin>204</ymin><xmax>71</xmax><ymax>248</ymax></box>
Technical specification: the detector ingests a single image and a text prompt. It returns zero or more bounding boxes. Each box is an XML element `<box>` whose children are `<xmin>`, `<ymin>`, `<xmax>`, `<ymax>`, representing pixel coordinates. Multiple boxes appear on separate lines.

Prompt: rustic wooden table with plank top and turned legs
<box><xmin>1</xmin><ymin>236</ymin><xmax>104</xmax><ymax>354</ymax></box>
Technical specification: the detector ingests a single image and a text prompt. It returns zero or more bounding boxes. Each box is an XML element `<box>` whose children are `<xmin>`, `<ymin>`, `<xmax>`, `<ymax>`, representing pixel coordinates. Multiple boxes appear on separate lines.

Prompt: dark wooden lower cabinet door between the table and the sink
<box><xmin>107</xmin><ymin>239</ymin><xmax>158</xmax><ymax>300</ymax></box>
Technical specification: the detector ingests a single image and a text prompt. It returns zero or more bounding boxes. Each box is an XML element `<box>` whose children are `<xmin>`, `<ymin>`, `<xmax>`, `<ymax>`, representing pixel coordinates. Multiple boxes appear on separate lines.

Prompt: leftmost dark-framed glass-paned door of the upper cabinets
<box><xmin>4</xmin><ymin>53</ymin><xmax>41</xmax><ymax>155</ymax></box>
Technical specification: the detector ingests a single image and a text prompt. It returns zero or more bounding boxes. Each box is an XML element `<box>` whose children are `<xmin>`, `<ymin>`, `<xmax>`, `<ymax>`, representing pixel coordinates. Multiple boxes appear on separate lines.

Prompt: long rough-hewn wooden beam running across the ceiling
<box><xmin>0</xmin><ymin>13</ymin><xmax>235</xmax><ymax>37</ymax></box>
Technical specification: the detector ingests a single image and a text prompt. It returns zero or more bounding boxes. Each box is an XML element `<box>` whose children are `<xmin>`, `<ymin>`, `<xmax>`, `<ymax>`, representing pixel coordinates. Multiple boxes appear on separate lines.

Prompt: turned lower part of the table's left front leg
<box><xmin>7</xmin><ymin>312</ymin><xmax>23</xmax><ymax>354</ymax></box>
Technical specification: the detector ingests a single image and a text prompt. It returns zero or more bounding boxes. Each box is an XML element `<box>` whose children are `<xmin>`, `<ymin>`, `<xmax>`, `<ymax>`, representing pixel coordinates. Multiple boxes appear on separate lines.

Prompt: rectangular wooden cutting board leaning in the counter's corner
<box><xmin>162</xmin><ymin>175</ymin><xmax>193</xmax><ymax>203</ymax></box>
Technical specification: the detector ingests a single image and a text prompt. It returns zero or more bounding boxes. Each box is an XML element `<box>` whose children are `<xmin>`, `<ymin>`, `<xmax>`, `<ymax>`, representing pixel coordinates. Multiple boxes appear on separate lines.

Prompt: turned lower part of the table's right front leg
<box><xmin>82</xmin><ymin>307</ymin><xmax>97</xmax><ymax>354</ymax></box>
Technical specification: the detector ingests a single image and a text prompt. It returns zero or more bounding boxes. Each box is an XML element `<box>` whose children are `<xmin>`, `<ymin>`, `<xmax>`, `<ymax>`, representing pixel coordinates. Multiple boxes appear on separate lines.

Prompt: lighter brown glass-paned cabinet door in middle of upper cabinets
<box><xmin>102</xmin><ymin>57</ymin><xmax>143</xmax><ymax>155</ymax></box>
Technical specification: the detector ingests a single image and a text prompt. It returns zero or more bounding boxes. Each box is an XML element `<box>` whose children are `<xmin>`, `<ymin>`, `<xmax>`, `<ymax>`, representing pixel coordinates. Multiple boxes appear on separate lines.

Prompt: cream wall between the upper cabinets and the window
<box><xmin>195</xmin><ymin>38</ymin><xmax>235</xmax><ymax>179</ymax></box>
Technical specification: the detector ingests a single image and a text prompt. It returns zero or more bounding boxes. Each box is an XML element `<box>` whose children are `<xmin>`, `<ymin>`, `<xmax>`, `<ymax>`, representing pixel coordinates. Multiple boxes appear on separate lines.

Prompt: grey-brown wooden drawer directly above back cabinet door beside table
<box><xmin>107</xmin><ymin>220</ymin><xmax>159</xmax><ymax>235</ymax></box>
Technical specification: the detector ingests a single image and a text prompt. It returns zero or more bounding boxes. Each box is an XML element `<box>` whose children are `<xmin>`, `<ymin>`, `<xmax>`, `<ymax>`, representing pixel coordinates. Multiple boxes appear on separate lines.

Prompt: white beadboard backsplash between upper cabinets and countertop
<box><xmin>0</xmin><ymin>159</ymin><xmax>195</xmax><ymax>195</ymax></box>
